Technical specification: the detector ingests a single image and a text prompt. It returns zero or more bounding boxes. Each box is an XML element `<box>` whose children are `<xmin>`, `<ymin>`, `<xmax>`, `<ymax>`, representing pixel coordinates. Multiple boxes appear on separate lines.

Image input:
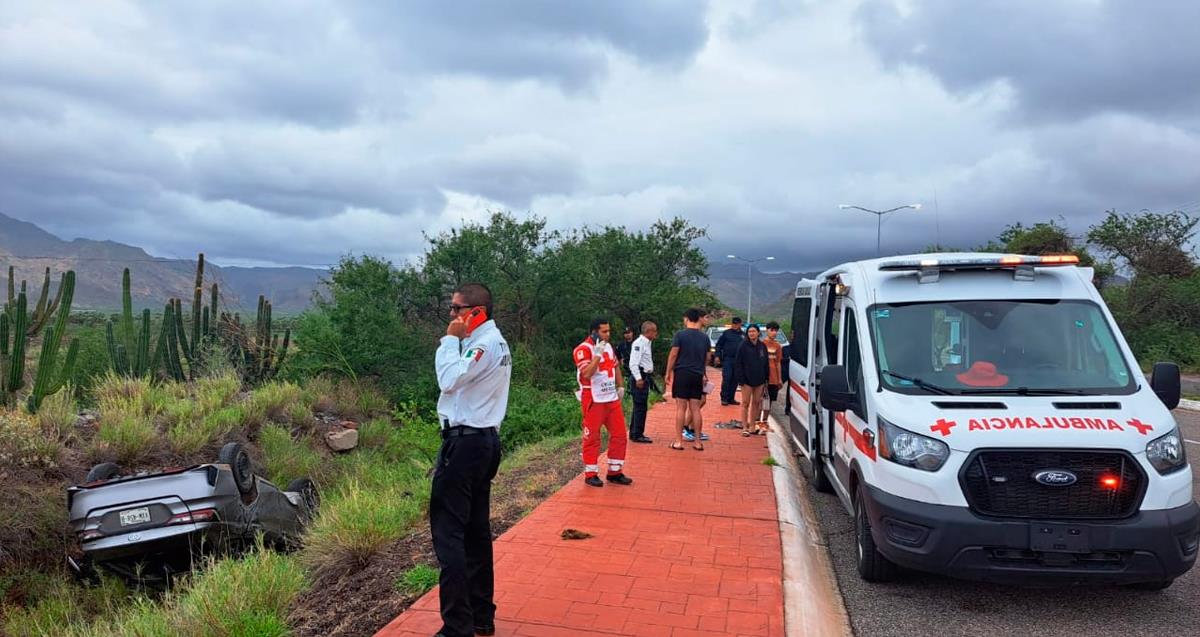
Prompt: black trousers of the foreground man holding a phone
<box><xmin>430</xmin><ymin>428</ymin><xmax>500</xmax><ymax>637</ymax></box>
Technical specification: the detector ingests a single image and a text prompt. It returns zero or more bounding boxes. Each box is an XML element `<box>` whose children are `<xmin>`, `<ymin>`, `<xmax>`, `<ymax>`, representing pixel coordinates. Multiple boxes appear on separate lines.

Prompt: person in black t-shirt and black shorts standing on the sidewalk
<box><xmin>666</xmin><ymin>307</ymin><xmax>709</xmax><ymax>451</ymax></box>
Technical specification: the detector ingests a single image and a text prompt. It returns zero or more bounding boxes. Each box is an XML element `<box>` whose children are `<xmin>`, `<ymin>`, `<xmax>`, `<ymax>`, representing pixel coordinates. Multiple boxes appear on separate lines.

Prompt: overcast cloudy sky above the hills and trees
<box><xmin>0</xmin><ymin>0</ymin><xmax>1200</xmax><ymax>269</ymax></box>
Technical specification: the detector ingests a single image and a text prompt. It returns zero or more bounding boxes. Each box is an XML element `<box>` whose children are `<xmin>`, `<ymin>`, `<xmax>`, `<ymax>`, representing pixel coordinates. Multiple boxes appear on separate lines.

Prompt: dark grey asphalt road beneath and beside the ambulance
<box><xmin>804</xmin><ymin>410</ymin><xmax>1200</xmax><ymax>637</ymax></box>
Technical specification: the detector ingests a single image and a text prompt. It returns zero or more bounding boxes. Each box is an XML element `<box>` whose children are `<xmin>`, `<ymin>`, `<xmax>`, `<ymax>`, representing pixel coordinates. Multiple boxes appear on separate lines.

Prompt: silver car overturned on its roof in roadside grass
<box><xmin>67</xmin><ymin>443</ymin><xmax>319</xmax><ymax>585</ymax></box>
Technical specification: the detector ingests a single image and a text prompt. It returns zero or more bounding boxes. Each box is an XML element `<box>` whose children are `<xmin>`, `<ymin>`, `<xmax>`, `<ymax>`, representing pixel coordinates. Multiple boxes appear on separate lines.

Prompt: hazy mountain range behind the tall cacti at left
<box><xmin>0</xmin><ymin>215</ymin><xmax>325</xmax><ymax>313</ymax></box>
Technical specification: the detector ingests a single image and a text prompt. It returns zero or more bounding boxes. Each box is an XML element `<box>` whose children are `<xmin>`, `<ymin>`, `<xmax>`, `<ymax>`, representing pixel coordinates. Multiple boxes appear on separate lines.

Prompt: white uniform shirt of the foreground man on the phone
<box><xmin>434</xmin><ymin>320</ymin><xmax>512</xmax><ymax>428</ymax></box>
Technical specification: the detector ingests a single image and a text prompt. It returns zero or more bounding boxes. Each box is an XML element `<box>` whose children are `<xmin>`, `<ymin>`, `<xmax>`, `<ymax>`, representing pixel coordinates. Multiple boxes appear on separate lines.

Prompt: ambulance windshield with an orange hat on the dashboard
<box><xmin>869</xmin><ymin>300</ymin><xmax>1136</xmax><ymax>395</ymax></box>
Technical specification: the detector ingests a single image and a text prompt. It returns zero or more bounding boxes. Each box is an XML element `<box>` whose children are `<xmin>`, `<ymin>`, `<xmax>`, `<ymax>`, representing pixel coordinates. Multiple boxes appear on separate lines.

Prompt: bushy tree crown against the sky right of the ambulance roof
<box><xmin>1087</xmin><ymin>210</ymin><xmax>1200</xmax><ymax>276</ymax></box>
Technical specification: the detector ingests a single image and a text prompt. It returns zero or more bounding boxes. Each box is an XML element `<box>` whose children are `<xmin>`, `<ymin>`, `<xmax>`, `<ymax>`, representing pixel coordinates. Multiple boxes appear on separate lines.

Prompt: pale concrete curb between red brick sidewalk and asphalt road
<box><xmin>767</xmin><ymin>416</ymin><xmax>853</xmax><ymax>637</ymax></box>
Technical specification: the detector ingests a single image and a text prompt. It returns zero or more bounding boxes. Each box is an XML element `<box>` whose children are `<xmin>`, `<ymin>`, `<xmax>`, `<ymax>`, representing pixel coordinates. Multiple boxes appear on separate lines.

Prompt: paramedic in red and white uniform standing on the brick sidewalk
<box><xmin>574</xmin><ymin>319</ymin><xmax>634</xmax><ymax>487</ymax></box>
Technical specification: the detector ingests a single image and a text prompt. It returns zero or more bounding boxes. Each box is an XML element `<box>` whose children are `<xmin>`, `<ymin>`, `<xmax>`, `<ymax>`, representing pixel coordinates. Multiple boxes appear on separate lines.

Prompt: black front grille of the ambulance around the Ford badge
<box><xmin>959</xmin><ymin>449</ymin><xmax>1146</xmax><ymax>519</ymax></box>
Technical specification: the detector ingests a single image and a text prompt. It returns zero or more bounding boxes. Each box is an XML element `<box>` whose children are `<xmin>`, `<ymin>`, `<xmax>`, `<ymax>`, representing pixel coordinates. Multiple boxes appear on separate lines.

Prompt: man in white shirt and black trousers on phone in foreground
<box><xmin>430</xmin><ymin>283</ymin><xmax>512</xmax><ymax>637</ymax></box>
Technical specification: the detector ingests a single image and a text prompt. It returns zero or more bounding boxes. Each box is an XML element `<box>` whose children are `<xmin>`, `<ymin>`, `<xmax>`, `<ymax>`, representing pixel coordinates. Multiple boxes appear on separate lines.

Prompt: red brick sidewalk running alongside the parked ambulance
<box><xmin>377</xmin><ymin>374</ymin><xmax>784</xmax><ymax>637</ymax></box>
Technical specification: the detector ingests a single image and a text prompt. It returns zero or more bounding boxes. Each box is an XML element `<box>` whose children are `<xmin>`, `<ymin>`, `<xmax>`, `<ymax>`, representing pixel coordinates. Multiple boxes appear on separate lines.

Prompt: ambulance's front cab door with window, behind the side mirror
<box><xmin>833</xmin><ymin>299</ymin><xmax>875</xmax><ymax>495</ymax></box>
